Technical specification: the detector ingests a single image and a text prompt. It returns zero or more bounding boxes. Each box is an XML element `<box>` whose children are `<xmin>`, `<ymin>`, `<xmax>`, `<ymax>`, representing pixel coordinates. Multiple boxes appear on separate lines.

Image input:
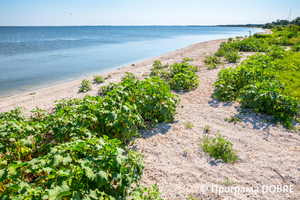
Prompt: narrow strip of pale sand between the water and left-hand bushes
<box><xmin>0</xmin><ymin>38</ymin><xmax>227</xmax><ymax>113</ymax></box>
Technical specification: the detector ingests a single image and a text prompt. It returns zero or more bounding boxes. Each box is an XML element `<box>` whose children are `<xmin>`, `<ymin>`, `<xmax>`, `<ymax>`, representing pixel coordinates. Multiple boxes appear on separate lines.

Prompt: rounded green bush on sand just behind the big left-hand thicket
<box><xmin>152</xmin><ymin>60</ymin><xmax>199</xmax><ymax>91</ymax></box>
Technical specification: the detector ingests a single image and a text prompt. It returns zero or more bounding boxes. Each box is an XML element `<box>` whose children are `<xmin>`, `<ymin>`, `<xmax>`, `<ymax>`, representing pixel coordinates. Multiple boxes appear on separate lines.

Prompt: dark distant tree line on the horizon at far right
<box><xmin>219</xmin><ymin>17</ymin><xmax>300</xmax><ymax>29</ymax></box>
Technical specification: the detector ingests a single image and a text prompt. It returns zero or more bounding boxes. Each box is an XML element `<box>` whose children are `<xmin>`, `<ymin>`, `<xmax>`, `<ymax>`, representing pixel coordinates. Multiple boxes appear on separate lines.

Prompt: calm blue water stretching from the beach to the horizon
<box><xmin>0</xmin><ymin>26</ymin><xmax>262</xmax><ymax>97</ymax></box>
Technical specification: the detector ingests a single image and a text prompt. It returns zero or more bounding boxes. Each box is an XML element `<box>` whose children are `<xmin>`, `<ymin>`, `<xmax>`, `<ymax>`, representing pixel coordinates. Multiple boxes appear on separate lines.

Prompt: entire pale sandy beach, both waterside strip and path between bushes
<box><xmin>0</xmin><ymin>34</ymin><xmax>300</xmax><ymax>200</ymax></box>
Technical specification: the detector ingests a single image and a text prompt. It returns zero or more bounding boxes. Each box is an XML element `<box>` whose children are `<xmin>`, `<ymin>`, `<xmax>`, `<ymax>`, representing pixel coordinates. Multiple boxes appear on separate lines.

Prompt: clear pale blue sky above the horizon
<box><xmin>0</xmin><ymin>0</ymin><xmax>300</xmax><ymax>26</ymax></box>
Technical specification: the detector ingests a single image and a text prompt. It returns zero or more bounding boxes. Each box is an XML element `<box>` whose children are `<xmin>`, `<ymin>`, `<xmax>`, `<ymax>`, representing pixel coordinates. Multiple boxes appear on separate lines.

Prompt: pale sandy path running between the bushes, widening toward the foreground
<box><xmin>134</xmin><ymin>45</ymin><xmax>300</xmax><ymax>200</ymax></box>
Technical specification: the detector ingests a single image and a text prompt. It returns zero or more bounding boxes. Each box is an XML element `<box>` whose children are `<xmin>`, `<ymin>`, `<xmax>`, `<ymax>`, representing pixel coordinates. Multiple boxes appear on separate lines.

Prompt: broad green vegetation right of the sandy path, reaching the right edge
<box><xmin>214</xmin><ymin>26</ymin><xmax>300</xmax><ymax>129</ymax></box>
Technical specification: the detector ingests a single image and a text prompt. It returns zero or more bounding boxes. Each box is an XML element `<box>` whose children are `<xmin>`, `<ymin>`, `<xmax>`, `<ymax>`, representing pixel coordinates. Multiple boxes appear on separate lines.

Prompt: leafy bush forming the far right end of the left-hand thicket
<box><xmin>107</xmin><ymin>77</ymin><xmax>179</xmax><ymax>125</ymax></box>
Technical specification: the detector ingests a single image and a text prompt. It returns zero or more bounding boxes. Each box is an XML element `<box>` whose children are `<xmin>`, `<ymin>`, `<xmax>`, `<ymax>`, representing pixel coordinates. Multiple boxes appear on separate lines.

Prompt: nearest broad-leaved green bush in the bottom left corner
<box><xmin>0</xmin><ymin>138</ymin><xmax>148</xmax><ymax>199</ymax></box>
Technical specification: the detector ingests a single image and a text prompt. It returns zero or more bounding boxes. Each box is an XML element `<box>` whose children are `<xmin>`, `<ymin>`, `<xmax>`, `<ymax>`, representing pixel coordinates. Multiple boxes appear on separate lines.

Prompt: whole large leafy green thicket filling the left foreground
<box><xmin>0</xmin><ymin>74</ymin><xmax>180</xmax><ymax>199</ymax></box>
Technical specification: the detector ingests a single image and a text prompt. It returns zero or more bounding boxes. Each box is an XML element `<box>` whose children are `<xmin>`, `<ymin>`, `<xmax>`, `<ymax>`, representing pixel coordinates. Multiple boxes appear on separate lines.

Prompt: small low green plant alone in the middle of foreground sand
<box><xmin>199</xmin><ymin>134</ymin><xmax>238</xmax><ymax>163</ymax></box>
